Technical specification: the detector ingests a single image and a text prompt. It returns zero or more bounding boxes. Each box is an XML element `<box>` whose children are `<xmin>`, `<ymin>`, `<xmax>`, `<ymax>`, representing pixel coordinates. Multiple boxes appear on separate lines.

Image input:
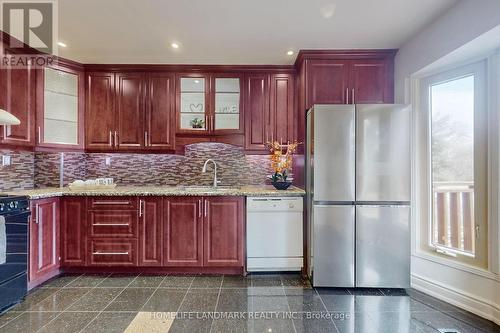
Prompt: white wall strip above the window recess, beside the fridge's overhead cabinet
<box><xmin>394</xmin><ymin>0</ymin><xmax>500</xmax><ymax>103</ymax></box>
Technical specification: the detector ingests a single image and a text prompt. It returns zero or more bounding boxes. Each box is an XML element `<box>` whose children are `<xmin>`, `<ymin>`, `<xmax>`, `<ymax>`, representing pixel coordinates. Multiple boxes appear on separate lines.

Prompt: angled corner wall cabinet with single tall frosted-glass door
<box><xmin>36</xmin><ymin>67</ymin><xmax>84</xmax><ymax>148</ymax></box>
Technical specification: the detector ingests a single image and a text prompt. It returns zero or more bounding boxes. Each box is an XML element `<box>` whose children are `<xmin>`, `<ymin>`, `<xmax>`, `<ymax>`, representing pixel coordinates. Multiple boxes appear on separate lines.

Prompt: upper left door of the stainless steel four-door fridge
<box><xmin>308</xmin><ymin>105</ymin><xmax>356</xmax><ymax>201</ymax></box>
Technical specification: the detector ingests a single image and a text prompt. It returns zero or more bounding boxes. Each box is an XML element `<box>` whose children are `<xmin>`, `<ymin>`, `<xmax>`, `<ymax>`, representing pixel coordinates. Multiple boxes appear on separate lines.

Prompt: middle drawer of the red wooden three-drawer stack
<box><xmin>88</xmin><ymin>210</ymin><xmax>137</xmax><ymax>238</ymax></box>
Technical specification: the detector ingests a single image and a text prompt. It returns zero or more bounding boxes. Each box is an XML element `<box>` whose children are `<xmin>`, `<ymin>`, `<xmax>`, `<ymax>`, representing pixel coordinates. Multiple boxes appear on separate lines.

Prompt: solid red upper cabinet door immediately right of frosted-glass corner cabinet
<box><xmin>85</xmin><ymin>72</ymin><xmax>116</xmax><ymax>150</ymax></box>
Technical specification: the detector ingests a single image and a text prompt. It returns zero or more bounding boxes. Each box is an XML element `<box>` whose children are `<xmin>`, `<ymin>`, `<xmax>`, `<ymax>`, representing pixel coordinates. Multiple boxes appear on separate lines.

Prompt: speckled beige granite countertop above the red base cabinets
<box><xmin>7</xmin><ymin>185</ymin><xmax>305</xmax><ymax>199</ymax></box>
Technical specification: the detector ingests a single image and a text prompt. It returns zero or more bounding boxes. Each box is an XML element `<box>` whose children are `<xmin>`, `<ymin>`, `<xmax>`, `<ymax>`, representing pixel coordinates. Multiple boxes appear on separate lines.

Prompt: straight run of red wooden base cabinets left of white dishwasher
<box><xmin>56</xmin><ymin>196</ymin><xmax>244</xmax><ymax>272</ymax></box>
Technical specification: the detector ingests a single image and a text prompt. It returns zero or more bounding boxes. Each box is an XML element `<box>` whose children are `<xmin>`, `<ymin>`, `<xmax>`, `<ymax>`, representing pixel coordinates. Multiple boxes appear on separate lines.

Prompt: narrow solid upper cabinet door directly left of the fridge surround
<box><xmin>270</xmin><ymin>74</ymin><xmax>295</xmax><ymax>143</ymax></box>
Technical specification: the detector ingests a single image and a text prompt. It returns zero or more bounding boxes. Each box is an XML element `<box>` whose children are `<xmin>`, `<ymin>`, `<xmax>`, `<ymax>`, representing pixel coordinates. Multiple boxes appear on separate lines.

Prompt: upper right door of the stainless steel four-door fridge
<box><xmin>356</xmin><ymin>104</ymin><xmax>411</xmax><ymax>201</ymax></box>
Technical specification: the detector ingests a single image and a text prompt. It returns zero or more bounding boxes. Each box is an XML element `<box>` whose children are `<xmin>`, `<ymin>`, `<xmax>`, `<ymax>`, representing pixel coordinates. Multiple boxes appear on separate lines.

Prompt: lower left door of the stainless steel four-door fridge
<box><xmin>313</xmin><ymin>205</ymin><xmax>355</xmax><ymax>287</ymax></box>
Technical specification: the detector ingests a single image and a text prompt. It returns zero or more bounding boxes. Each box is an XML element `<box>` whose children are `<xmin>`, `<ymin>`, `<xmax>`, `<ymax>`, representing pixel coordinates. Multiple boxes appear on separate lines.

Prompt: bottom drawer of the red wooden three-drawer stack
<box><xmin>88</xmin><ymin>239</ymin><xmax>137</xmax><ymax>266</ymax></box>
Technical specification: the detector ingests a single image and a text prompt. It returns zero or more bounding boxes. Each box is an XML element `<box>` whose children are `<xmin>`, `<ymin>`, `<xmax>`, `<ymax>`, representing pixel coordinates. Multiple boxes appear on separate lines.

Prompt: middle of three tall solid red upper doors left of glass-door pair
<box><xmin>115</xmin><ymin>73</ymin><xmax>144</xmax><ymax>150</ymax></box>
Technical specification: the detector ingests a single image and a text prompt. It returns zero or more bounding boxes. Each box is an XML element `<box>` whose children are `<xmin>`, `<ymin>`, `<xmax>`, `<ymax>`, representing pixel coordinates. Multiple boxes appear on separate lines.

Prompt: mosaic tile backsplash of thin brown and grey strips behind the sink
<box><xmin>0</xmin><ymin>143</ymin><xmax>282</xmax><ymax>191</ymax></box>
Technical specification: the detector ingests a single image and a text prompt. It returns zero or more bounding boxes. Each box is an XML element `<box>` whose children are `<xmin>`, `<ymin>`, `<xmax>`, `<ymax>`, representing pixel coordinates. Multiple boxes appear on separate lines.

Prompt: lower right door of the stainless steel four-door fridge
<box><xmin>356</xmin><ymin>206</ymin><xmax>411</xmax><ymax>288</ymax></box>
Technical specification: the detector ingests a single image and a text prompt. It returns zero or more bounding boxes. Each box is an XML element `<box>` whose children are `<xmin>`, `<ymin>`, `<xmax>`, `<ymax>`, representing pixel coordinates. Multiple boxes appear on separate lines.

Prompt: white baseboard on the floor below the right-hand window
<box><xmin>411</xmin><ymin>274</ymin><xmax>500</xmax><ymax>325</ymax></box>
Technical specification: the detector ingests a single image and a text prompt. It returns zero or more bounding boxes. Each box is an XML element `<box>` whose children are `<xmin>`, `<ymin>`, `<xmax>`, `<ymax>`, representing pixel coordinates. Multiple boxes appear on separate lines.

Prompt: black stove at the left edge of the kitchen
<box><xmin>0</xmin><ymin>194</ymin><xmax>31</xmax><ymax>313</ymax></box>
